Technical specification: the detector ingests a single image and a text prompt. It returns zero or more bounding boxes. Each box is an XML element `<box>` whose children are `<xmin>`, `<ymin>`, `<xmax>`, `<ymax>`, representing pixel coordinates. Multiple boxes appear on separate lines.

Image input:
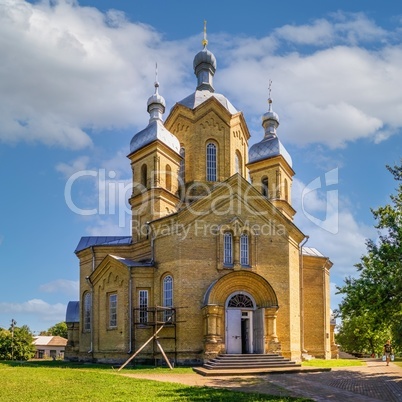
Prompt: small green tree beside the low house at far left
<box><xmin>0</xmin><ymin>325</ymin><xmax>36</xmax><ymax>360</ymax></box>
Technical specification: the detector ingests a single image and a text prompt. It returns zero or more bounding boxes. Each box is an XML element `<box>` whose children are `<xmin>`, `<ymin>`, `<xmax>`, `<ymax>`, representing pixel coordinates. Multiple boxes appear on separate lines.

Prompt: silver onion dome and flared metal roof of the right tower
<box><xmin>248</xmin><ymin>98</ymin><xmax>292</xmax><ymax>167</ymax></box>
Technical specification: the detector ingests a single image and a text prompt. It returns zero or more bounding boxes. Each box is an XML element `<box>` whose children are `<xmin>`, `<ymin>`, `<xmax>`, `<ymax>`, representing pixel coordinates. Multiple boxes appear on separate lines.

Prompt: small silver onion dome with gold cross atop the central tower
<box><xmin>193</xmin><ymin>21</ymin><xmax>216</xmax><ymax>92</ymax></box>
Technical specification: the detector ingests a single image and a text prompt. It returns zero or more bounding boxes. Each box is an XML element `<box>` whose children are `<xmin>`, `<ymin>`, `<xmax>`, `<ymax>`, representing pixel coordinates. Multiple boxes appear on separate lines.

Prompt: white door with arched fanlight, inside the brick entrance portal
<box><xmin>226</xmin><ymin>292</ymin><xmax>256</xmax><ymax>354</ymax></box>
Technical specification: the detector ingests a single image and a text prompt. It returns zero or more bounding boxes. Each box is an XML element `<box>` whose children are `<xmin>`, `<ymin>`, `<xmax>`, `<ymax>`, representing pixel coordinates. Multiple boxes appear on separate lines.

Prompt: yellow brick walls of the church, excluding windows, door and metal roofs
<box><xmin>67</xmin><ymin>92</ymin><xmax>330</xmax><ymax>362</ymax></box>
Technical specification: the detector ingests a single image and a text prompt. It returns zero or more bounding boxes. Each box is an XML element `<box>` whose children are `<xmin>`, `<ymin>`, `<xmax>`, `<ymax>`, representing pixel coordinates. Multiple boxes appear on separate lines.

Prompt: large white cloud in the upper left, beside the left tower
<box><xmin>0</xmin><ymin>0</ymin><xmax>192</xmax><ymax>149</ymax></box>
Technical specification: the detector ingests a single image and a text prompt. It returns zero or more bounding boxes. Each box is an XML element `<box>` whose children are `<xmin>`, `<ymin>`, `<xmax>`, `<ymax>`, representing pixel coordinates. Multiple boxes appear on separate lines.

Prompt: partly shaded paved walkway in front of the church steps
<box><xmin>123</xmin><ymin>359</ymin><xmax>402</xmax><ymax>402</ymax></box>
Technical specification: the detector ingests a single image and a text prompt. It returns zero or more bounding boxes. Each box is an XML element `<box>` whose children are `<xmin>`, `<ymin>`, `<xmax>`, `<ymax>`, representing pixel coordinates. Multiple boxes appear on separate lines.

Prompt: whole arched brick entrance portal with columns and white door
<box><xmin>203</xmin><ymin>270</ymin><xmax>279</xmax><ymax>358</ymax></box>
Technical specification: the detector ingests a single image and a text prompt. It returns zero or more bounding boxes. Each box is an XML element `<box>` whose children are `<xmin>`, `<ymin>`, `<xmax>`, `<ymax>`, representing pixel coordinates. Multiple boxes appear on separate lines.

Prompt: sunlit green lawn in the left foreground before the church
<box><xmin>0</xmin><ymin>361</ymin><xmax>310</xmax><ymax>402</ymax></box>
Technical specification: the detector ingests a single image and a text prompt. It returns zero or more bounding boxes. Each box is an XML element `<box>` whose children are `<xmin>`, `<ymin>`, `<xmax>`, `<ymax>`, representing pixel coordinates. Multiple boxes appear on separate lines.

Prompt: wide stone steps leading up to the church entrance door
<box><xmin>193</xmin><ymin>353</ymin><xmax>322</xmax><ymax>376</ymax></box>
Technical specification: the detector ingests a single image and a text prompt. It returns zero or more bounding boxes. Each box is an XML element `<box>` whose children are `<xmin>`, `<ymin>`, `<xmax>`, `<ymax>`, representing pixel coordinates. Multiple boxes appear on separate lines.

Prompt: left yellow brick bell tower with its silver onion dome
<box><xmin>128</xmin><ymin>74</ymin><xmax>182</xmax><ymax>242</ymax></box>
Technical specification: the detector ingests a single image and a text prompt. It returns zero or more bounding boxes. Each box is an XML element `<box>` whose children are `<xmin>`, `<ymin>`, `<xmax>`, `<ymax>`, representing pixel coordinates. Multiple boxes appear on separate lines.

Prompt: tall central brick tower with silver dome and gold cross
<box><xmin>165</xmin><ymin>22</ymin><xmax>250</xmax><ymax>200</ymax></box>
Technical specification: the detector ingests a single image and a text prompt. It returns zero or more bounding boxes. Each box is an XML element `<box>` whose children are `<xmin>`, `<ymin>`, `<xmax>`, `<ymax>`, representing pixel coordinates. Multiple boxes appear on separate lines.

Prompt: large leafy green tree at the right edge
<box><xmin>337</xmin><ymin>160</ymin><xmax>402</xmax><ymax>348</ymax></box>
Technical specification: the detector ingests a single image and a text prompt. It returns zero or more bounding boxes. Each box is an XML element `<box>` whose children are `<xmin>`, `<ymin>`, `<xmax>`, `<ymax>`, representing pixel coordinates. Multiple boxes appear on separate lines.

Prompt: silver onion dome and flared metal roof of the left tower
<box><xmin>130</xmin><ymin>82</ymin><xmax>180</xmax><ymax>154</ymax></box>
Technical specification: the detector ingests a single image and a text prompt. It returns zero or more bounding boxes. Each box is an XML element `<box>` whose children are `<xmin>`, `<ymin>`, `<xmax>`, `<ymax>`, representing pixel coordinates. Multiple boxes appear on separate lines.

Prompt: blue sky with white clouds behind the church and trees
<box><xmin>0</xmin><ymin>0</ymin><xmax>402</xmax><ymax>333</ymax></box>
